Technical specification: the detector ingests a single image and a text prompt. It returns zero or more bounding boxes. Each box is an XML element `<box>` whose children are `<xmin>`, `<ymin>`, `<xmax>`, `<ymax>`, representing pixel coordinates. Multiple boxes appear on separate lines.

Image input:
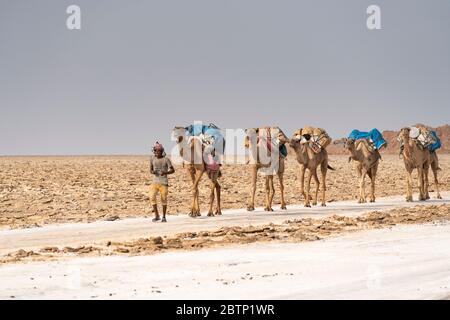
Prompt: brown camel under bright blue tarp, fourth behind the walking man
<box><xmin>345</xmin><ymin>139</ymin><xmax>381</xmax><ymax>203</ymax></box>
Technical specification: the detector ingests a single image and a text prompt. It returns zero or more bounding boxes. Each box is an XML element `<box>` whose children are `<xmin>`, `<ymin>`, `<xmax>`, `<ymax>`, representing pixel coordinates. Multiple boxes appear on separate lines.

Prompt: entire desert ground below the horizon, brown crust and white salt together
<box><xmin>0</xmin><ymin>154</ymin><xmax>450</xmax><ymax>299</ymax></box>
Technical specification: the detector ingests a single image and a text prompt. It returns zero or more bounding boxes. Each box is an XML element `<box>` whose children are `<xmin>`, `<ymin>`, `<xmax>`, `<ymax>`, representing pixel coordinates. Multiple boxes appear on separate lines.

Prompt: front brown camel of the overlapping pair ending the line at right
<box><xmin>398</xmin><ymin>128</ymin><xmax>432</xmax><ymax>202</ymax></box>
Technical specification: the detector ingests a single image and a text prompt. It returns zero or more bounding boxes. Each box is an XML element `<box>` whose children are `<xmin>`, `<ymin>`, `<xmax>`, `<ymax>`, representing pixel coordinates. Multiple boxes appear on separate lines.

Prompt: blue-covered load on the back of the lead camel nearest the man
<box><xmin>186</xmin><ymin>123</ymin><xmax>225</xmax><ymax>171</ymax></box>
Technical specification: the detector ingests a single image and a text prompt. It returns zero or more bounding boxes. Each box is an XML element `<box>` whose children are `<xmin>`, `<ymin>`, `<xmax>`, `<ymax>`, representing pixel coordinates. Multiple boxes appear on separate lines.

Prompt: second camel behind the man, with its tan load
<box><xmin>245</xmin><ymin>127</ymin><xmax>289</xmax><ymax>211</ymax></box>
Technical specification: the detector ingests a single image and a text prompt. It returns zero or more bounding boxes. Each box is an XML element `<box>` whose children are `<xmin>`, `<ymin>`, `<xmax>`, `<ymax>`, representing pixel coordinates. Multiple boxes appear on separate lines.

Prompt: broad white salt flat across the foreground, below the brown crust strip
<box><xmin>0</xmin><ymin>223</ymin><xmax>450</xmax><ymax>299</ymax></box>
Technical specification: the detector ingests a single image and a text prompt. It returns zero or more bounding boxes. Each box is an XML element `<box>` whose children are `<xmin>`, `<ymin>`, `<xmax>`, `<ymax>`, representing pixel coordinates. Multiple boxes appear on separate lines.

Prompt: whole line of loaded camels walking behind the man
<box><xmin>147</xmin><ymin>124</ymin><xmax>441</xmax><ymax>221</ymax></box>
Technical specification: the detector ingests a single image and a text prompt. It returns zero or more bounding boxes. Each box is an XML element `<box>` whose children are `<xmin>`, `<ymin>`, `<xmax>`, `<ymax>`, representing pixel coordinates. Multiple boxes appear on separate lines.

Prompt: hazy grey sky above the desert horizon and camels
<box><xmin>0</xmin><ymin>0</ymin><xmax>450</xmax><ymax>155</ymax></box>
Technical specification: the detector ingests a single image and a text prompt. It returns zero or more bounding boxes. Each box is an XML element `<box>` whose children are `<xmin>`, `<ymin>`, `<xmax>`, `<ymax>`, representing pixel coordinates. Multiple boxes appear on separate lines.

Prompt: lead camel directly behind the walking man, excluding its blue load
<box><xmin>173</xmin><ymin>127</ymin><xmax>222</xmax><ymax>218</ymax></box>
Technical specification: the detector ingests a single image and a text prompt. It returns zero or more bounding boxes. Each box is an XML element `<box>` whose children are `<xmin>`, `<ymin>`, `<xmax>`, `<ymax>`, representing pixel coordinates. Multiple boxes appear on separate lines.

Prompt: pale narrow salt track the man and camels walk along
<box><xmin>0</xmin><ymin>192</ymin><xmax>450</xmax><ymax>254</ymax></box>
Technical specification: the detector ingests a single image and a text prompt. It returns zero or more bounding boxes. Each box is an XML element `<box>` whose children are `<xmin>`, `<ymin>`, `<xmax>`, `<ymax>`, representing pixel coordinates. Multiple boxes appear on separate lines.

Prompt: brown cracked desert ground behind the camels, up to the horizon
<box><xmin>0</xmin><ymin>154</ymin><xmax>450</xmax><ymax>229</ymax></box>
